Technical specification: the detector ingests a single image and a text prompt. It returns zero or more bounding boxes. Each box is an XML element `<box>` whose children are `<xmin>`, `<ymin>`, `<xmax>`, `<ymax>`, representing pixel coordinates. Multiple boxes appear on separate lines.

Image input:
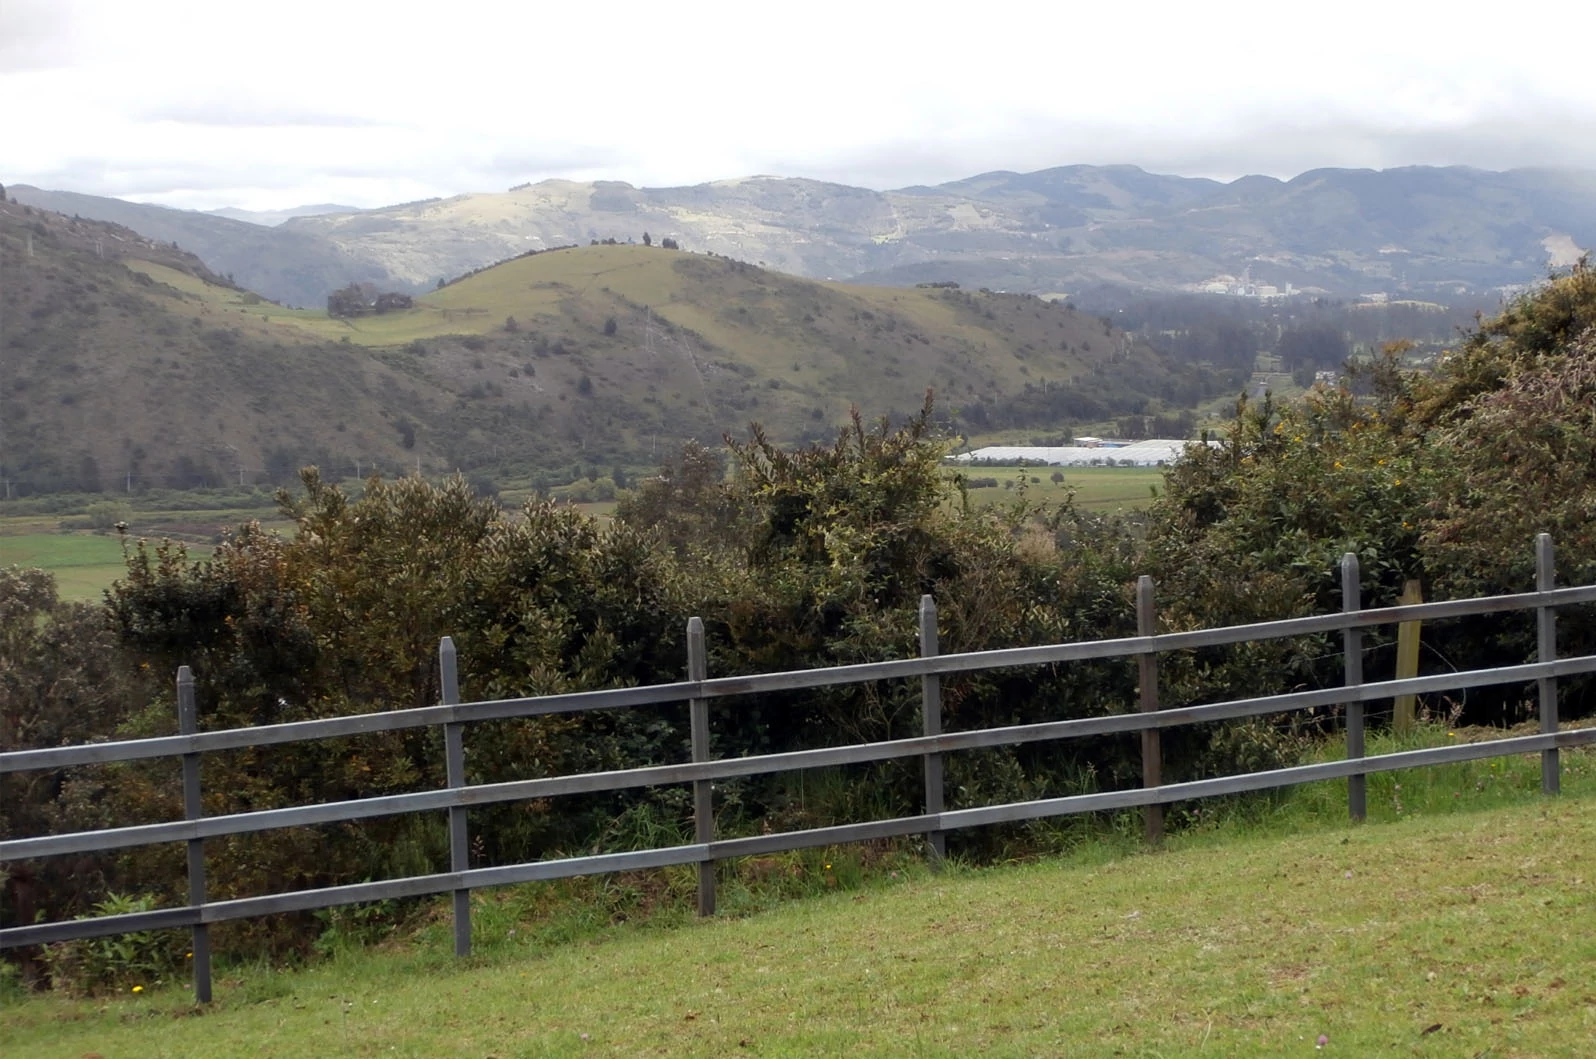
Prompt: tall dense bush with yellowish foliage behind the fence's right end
<box><xmin>1149</xmin><ymin>265</ymin><xmax>1596</xmax><ymax>721</ymax></box>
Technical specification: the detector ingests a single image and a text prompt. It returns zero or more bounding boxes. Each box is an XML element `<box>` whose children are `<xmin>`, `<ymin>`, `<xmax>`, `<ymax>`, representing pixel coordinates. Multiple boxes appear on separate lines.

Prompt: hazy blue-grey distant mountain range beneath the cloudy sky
<box><xmin>11</xmin><ymin>166</ymin><xmax>1596</xmax><ymax>305</ymax></box>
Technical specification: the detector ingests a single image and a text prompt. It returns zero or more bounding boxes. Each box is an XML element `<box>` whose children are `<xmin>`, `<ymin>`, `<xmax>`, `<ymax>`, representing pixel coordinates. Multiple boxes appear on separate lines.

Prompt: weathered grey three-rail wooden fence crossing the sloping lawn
<box><xmin>0</xmin><ymin>534</ymin><xmax>1596</xmax><ymax>1002</ymax></box>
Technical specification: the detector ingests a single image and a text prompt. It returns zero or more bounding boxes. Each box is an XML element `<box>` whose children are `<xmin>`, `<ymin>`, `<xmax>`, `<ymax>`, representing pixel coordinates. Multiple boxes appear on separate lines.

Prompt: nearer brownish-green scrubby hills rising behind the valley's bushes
<box><xmin>0</xmin><ymin>204</ymin><xmax>1235</xmax><ymax>491</ymax></box>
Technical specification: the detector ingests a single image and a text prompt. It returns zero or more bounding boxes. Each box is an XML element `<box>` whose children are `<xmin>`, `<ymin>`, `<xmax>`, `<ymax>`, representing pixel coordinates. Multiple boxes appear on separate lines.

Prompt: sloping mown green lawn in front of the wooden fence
<box><xmin>0</xmin><ymin>729</ymin><xmax>1596</xmax><ymax>1059</ymax></box>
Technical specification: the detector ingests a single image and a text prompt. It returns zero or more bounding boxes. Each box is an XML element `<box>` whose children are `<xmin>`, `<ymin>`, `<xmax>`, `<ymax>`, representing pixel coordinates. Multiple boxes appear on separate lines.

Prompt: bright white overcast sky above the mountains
<box><xmin>0</xmin><ymin>0</ymin><xmax>1596</xmax><ymax>209</ymax></box>
